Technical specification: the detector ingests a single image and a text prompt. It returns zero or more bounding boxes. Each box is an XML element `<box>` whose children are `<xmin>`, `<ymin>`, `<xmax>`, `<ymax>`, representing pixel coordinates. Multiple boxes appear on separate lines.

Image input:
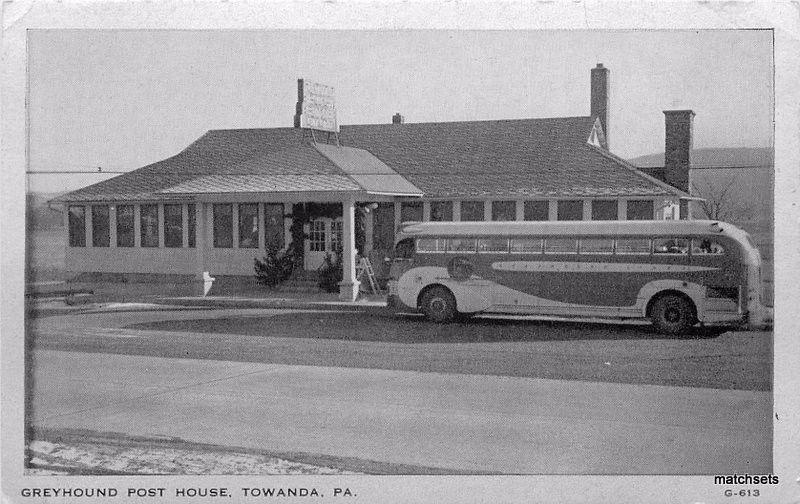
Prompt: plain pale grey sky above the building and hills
<box><xmin>29</xmin><ymin>30</ymin><xmax>773</xmax><ymax>192</ymax></box>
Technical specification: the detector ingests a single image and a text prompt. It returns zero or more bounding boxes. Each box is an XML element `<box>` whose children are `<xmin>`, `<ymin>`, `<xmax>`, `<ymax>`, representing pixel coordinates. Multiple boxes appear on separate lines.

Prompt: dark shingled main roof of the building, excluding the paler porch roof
<box><xmin>59</xmin><ymin>117</ymin><xmax>684</xmax><ymax>201</ymax></box>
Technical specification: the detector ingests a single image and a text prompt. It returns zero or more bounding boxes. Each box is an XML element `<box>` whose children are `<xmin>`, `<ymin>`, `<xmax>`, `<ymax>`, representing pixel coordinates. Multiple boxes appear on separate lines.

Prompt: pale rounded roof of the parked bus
<box><xmin>396</xmin><ymin>220</ymin><xmax>745</xmax><ymax>241</ymax></box>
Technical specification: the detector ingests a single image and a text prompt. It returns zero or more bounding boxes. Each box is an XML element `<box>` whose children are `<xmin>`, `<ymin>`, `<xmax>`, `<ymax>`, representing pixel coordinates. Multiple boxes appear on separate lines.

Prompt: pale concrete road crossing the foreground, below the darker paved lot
<box><xmin>32</xmin><ymin>350</ymin><xmax>772</xmax><ymax>474</ymax></box>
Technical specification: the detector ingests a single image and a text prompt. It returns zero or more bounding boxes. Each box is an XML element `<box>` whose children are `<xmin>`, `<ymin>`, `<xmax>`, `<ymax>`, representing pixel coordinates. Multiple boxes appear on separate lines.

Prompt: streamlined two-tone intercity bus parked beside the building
<box><xmin>388</xmin><ymin>220</ymin><xmax>764</xmax><ymax>334</ymax></box>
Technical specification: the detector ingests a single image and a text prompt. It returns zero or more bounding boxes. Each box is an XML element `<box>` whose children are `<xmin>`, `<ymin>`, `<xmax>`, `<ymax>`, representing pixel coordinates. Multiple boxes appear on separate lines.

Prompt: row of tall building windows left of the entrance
<box><xmin>68</xmin><ymin>203</ymin><xmax>284</xmax><ymax>248</ymax></box>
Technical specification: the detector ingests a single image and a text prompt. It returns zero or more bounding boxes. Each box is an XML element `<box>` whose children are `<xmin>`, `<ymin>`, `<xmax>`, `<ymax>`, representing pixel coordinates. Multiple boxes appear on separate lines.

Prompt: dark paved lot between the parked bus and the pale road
<box><xmin>30</xmin><ymin>309</ymin><xmax>772</xmax><ymax>391</ymax></box>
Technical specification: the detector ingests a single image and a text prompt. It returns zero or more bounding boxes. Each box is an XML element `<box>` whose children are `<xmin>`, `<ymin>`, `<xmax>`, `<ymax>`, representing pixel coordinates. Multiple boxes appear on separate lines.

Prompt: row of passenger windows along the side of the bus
<box><xmin>416</xmin><ymin>238</ymin><xmax>725</xmax><ymax>255</ymax></box>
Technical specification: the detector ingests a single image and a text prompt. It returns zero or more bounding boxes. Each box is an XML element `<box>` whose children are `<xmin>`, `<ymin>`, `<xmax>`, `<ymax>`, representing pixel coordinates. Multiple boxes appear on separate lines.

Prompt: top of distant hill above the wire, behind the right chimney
<box><xmin>628</xmin><ymin>147</ymin><xmax>774</xmax><ymax>169</ymax></box>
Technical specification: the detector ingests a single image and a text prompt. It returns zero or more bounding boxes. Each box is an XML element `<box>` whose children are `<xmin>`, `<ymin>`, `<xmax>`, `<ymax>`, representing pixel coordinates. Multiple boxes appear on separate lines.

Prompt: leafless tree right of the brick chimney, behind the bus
<box><xmin>691</xmin><ymin>175</ymin><xmax>756</xmax><ymax>221</ymax></box>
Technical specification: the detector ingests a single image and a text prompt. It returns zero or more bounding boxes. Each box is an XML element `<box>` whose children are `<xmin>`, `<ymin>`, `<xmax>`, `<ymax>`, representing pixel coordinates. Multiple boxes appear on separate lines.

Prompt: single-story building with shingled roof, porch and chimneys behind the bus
<box><xmin>56</xmin><ymin>64</ymin><xmax>694</xmax><ymax>299</ymax></box>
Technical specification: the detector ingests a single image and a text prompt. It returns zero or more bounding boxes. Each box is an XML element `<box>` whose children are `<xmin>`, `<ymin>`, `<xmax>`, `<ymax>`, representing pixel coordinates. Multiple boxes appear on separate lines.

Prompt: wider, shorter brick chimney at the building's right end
<box><xmin>664</xmin><ymin>110</ymin><xmax>694</xmax><ymax>193</ymax></box>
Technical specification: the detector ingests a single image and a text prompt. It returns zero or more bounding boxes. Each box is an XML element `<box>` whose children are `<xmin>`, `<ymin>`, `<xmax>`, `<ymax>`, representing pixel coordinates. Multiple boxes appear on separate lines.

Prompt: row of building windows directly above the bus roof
<box><xmin>400</xmin><ymin>200</ymin><xmax>655</xmax><ymax>222</ymax></box>
